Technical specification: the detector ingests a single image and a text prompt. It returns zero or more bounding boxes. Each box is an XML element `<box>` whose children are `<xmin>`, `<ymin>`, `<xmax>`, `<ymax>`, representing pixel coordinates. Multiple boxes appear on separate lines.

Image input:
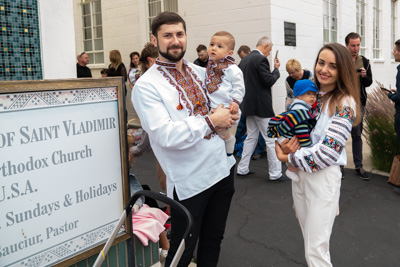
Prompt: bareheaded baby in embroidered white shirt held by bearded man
<box><xmin>205</xmin><ymin>31</ymin><xmax>244</xmax><ymax>155</ymax></box>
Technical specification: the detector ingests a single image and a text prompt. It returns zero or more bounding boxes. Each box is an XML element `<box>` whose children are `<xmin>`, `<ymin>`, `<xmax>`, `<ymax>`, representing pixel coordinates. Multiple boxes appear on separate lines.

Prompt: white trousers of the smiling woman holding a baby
<box><xmin>292</xmin><ymin>165</ymin><xmax>342</xmax><ymax>267</ymax></box>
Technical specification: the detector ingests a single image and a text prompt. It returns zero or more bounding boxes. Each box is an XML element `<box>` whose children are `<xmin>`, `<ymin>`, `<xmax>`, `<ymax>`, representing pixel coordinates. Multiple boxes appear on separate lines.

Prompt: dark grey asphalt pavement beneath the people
<box><xmin>129</xmin><ymin>89</ymin><xmax>400</xmax><ymax>267</ymax></box>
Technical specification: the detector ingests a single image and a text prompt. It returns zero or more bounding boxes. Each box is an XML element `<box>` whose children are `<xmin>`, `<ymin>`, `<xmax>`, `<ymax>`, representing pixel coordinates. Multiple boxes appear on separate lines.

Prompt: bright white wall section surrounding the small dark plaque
<box><xmin>269</xmin><ymin>0</ymin><xmax>323</xmax><ymax>113</ymax></box>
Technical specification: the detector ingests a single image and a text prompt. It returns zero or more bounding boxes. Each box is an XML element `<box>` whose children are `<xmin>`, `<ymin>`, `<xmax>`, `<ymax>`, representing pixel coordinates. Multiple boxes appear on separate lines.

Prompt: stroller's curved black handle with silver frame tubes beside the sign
<box><xmin>93</xmin><ymin>190</ymin><xmax>193</xmax><ymax>267</ymax></box>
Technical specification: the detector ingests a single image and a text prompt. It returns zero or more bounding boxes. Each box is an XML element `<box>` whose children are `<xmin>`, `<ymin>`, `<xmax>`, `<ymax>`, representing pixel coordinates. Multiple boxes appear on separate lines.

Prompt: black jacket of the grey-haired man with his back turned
<box><xmin>239</xmin><ymin>50</ymin><xmax>280</xmax><ymax>118</ymax></box>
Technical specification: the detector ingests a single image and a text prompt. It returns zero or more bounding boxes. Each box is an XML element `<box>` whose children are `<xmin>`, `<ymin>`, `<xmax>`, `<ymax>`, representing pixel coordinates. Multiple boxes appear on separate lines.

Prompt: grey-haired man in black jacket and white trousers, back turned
<box><xmin>237</xmin><ymin>36</ymin><xmax>290</xmax><ymax>182</ymax></box>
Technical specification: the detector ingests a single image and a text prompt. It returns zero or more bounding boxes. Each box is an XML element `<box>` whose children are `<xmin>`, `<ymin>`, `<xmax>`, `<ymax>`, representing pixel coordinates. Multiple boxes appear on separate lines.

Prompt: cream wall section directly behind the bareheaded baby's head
<box><xmin>179</xmin><ymin>0</ymin><xmax>271</xmax><ymax>62</ymax></box>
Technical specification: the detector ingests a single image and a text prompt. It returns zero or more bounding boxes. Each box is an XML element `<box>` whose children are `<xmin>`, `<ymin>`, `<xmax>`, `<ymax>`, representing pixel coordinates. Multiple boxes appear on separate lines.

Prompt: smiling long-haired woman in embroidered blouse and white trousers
<box><xmin>276</xmin><ymin>43</ymin><xmax>361</xmax><ymax>267</ymax></box>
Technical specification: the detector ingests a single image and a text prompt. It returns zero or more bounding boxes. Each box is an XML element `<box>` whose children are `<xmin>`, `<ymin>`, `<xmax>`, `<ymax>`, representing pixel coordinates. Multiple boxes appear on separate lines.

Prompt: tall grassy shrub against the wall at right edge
<box><xmin>363</xmin><ymin>87</ymin><xmax>400</xmax><ymax>172</ymax></box>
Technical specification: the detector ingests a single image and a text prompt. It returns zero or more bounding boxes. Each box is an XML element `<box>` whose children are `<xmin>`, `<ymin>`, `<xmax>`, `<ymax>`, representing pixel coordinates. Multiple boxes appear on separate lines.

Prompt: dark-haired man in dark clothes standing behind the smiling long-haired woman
<box><xmin>341</xmin><ymin>32</ymin><xmax>372</xmax><ymax>181</ymax></box>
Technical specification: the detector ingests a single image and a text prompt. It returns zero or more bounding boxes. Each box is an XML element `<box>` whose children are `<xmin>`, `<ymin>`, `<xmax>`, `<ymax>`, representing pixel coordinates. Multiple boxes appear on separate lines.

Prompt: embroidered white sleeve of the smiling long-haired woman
<box><xmin>289</xmin><ymin>101</ymin><xmax>355</xmax><ymax>173</ymax></box>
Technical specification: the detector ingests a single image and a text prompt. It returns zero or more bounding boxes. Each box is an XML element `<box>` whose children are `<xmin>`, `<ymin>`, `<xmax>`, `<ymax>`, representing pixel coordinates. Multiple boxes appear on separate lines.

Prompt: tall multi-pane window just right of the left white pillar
<box><xmin>82</xmin><ymin>0</ymin><xmax>104</xmax><ymax>64</ymax></box>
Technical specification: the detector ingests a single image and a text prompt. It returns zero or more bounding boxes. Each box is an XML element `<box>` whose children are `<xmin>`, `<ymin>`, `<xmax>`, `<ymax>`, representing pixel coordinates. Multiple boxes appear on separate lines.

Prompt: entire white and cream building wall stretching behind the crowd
<box><xmin>74</xmin><ymin>0</ymin><xmax>400</xmax><ymax>113</ymax></box>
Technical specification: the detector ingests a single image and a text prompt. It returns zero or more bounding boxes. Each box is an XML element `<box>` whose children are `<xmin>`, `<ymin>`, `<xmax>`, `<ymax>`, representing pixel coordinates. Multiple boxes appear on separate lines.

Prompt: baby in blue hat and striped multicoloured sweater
<box><xmin>268</xmin><ymin>80</ymin><xmax>318</xmax><ymax>182</ymax></box>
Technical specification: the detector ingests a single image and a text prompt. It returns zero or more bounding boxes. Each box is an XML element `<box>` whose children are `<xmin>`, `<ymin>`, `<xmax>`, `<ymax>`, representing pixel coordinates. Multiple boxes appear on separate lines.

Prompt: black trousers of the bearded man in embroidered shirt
<box><xmin>165</xmin><ymin>167</ymin><xmax>235</xmax><ymax>267</ymax></box>
